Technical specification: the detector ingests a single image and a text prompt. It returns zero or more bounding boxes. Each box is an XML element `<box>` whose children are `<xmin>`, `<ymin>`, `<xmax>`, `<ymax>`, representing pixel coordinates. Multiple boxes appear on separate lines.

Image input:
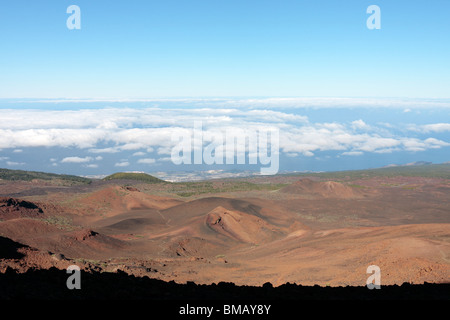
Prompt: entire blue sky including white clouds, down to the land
<box><xmin>0</xmin><ymin>0</ymin><xmax>450</xmax><ymax>175</ymax></box>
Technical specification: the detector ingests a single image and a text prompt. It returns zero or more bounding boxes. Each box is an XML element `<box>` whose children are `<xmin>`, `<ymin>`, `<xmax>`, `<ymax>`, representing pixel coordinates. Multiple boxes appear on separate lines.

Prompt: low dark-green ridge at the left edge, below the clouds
<box><xmin>0</xmin><ymin>169</ymin><xmax>92</xmax><ymax>183</ymax></box>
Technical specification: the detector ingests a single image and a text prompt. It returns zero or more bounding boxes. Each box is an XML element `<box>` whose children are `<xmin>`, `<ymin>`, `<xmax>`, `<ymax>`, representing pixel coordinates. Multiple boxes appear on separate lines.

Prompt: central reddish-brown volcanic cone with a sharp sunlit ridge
<box><xmin>156</xmin><ymin>197</ymin><xmax>303</xmax><ymax>242</ymax></box>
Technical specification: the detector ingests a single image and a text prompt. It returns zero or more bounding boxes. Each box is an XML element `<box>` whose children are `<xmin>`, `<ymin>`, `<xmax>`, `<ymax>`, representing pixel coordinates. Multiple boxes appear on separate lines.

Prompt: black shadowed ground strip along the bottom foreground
<box><xmin>0</xmin><ymin>268</ymin><xmax>450</xmax><ymax>301</ymax></box>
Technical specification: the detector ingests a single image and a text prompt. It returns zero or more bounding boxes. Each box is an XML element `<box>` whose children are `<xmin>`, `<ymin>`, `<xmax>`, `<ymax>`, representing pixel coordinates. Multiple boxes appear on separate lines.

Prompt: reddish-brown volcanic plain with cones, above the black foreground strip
<box><xmin>0</xmin><ymin>177</ymin><xmax>450</xmax><ymax>286</ymax></box>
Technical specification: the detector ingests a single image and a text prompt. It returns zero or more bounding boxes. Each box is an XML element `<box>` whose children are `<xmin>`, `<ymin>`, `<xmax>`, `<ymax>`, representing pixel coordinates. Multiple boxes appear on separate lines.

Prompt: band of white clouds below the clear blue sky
<box><xmin>0</xmin><ymin>105</ymin><xmax>450</xmax><ymax>168</ymax></box>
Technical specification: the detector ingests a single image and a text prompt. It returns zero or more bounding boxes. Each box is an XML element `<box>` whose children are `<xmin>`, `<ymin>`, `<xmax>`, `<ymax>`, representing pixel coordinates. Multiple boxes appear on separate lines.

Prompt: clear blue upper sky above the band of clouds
<box><xmin>0</xmin><ymin>0</ymin><xmax>450</xmax><ymax>98</ymax></box>
